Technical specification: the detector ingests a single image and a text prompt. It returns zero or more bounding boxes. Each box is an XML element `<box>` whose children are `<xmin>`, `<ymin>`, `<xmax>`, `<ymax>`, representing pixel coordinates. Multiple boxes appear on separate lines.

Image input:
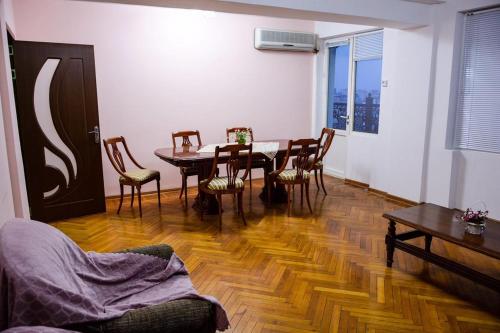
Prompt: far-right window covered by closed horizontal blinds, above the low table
<box><xmin>454</xmin><ymin>8</ymin><xmax>500</xmax><ymax>153</ymax></box>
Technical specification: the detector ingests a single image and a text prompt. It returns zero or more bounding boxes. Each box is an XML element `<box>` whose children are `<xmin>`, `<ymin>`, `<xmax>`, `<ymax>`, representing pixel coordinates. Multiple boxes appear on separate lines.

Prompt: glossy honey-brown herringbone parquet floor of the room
<box><xmin>53</xmin><ymin>177</ymin><xmax>500</xmax><ymax>332</ymax></box>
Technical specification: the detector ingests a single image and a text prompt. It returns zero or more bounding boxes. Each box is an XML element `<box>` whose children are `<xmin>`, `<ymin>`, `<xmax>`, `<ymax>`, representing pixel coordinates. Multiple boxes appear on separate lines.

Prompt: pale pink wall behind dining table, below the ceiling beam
<box><xmin>10</xmin><ymin>0</ymin><xmax>314</xmax><ymax>195</ymax></box>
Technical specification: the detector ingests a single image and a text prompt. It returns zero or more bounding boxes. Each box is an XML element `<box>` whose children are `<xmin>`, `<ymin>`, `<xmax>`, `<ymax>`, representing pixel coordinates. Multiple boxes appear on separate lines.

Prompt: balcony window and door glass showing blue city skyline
<box><xmin>327</xmin><ymin>31</ymin><xmax>383</xmax><ymax>134</ymax></box>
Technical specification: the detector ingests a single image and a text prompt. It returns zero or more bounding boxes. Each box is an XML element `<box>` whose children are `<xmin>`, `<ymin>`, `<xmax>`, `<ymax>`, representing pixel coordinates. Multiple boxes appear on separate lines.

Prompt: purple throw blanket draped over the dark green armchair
<box><xmin>0</xmin><ymin>219</ymin><xmax>229</xmax><ymax>332</ymax></box>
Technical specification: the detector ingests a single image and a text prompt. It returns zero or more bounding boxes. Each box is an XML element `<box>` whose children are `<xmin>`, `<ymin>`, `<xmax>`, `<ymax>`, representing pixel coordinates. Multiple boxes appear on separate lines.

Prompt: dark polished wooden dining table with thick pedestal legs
<box><xmin>154</xmin><ymin>139</ymin><xmax>306</xmax><ymax>214</ymax></box>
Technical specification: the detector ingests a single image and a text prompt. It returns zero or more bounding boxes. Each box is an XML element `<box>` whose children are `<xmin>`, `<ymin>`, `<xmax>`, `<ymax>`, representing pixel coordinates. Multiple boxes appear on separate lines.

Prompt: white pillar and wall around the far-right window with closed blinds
<box><xmin>424</xmin><ymin>0</ymin><xmax>500</xmax><ymax>219</ymax></box>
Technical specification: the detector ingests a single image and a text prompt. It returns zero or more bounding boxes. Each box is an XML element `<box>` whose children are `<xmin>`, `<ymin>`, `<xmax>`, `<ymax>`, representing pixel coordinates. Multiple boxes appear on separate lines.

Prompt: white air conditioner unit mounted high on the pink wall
<box><xmin>255</xmin><ymin>28</ymin><xmax>317</xmax><ymax>52</ymax></box>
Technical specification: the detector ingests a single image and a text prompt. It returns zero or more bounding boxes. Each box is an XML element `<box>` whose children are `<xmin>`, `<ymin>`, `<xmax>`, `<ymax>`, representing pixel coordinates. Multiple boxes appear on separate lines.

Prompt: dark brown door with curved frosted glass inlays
<box><xmin>13</xmin><ymin>41</ymin><xmax>106</xmax><ymax>222</ymax></box>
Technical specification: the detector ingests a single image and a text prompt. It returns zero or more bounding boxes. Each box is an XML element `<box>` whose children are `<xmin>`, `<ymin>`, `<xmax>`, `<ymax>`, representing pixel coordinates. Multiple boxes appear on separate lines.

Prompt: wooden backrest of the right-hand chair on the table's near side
<box><xmin>276</xmin><ymin>139</ymin><xmax>321</xmax><ymax>179</ymax></box>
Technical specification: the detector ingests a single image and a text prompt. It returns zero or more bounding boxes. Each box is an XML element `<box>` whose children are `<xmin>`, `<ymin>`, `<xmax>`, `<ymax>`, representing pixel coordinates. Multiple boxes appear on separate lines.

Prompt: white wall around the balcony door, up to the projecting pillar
<box><xmin>313</xmin><ymin>22</ymin><xmax>433</xmax><ymax>201</ymax></box>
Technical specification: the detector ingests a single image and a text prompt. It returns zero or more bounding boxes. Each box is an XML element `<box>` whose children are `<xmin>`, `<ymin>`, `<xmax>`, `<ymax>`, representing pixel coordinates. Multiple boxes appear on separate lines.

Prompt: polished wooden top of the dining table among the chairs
<box><xmin>154</xmin><ymin>139</ymin><xmax>289</xmax><ymax>165</ymax></box>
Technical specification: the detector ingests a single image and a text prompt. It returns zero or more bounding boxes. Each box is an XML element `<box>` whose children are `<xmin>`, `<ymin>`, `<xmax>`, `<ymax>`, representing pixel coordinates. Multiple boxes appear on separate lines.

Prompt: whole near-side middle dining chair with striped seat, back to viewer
<box><xmin>198</xmin><ymin>144</ymin><xmax>252</xmax><ymax>230</ymax></box>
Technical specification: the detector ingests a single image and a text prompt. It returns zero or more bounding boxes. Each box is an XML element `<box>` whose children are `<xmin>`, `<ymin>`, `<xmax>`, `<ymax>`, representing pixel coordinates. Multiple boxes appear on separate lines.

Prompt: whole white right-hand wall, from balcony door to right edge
<box><xmin>313</xmin><ymin>0</ymin><xmax>500</xmax><ymax>219</ymax></box>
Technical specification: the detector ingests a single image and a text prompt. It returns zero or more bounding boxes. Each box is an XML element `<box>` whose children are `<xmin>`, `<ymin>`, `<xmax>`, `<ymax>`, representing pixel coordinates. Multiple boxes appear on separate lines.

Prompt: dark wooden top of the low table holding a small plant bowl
<box><xmin>383</xmin><ymin>203</ymin><xmax>500</xmax><ymax>259</ymax></box>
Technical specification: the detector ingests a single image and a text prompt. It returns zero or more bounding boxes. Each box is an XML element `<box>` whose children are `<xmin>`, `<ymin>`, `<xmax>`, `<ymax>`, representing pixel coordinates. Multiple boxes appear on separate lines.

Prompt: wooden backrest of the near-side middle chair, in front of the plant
<box><xmin>207</xmin><ymin>143</ymin><xmax>252</xmax><ymax>189</ymax></box>
